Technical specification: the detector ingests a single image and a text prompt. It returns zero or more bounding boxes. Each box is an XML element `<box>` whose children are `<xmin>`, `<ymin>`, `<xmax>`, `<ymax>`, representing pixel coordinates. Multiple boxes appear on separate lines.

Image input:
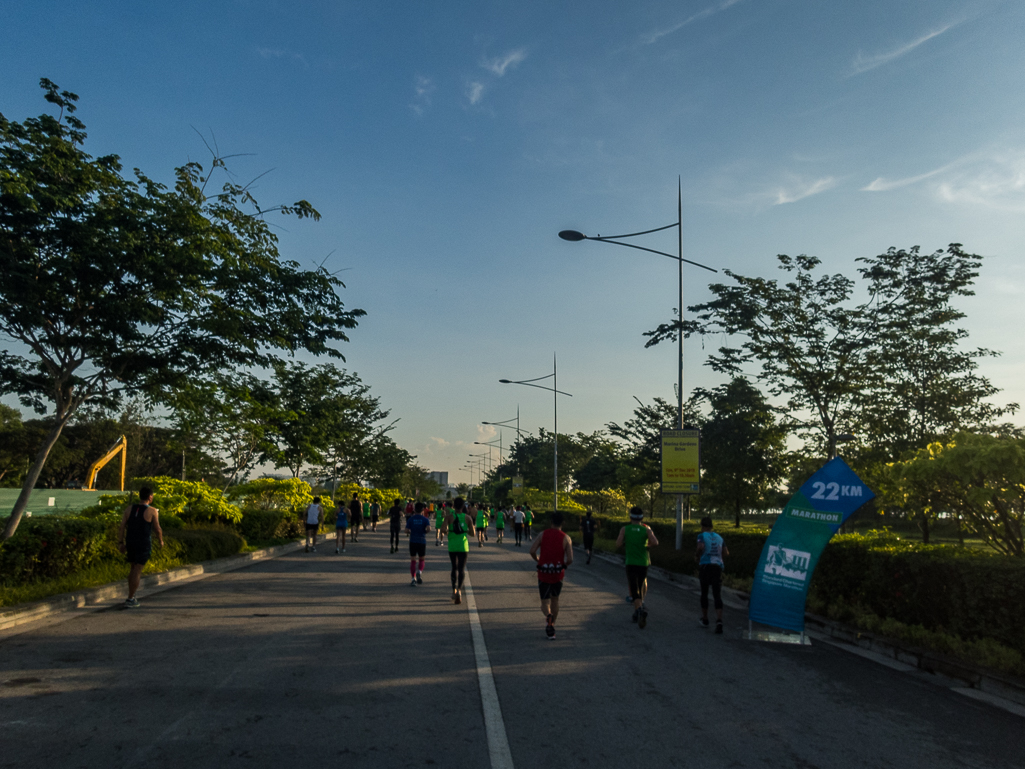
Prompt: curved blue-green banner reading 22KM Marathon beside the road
<box><xmin>747</xmin><ymin>456</ymin><xmax>875</xmax><ymax>633</ymax></box>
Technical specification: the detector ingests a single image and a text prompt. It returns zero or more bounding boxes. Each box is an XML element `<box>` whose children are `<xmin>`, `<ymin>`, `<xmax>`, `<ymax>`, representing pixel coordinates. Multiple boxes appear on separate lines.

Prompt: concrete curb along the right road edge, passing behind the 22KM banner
<box><xmin>574</xmin><ymin>545</ymin><xmax>1025</xmax><ymax>704</ymax></box>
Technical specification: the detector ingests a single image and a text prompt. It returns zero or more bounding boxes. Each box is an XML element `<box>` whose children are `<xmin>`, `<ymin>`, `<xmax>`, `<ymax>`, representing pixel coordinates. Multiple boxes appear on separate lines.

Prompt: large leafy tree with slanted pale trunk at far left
<box><xmin>0</xmin><ymin>79</ymin><xmax>363</xmax><ymax>538</ymax></box>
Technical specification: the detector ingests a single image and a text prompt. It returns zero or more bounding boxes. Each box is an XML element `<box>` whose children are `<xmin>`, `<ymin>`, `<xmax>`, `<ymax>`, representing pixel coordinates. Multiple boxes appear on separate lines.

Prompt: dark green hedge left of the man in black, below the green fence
<box><xmin>0</xmin><ymin>516</ymin><xmax>108</xmax><ymax>586</ymax></box>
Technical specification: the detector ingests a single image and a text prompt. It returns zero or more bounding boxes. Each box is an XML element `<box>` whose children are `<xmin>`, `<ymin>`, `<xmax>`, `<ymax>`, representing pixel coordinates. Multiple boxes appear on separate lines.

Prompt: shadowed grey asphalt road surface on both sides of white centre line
<box><xmin>0</xmin><ymin>531</ymin><xmax>1025</xmax><ymax>769</ymax></box>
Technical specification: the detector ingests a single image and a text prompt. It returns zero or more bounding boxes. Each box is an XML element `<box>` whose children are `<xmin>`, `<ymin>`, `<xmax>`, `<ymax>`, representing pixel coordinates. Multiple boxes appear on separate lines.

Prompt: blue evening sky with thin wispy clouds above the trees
<box><xmin>0</xmin><ymin>0</ymin><xmax>1025</xmax><ymax>482</ymax></box>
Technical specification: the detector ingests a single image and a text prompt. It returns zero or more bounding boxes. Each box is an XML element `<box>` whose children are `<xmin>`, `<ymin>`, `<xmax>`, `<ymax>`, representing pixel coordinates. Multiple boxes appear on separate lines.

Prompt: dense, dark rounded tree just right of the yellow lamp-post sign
<box><xmin>698</xmin><ymin>377</ymin><xmax>786</xmax><ymax>528</ymax></box>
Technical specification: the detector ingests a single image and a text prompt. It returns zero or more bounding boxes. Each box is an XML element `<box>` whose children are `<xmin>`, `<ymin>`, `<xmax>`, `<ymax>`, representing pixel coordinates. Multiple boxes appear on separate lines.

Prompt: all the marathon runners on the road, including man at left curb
<box><xmin>118</xmin><ymin>487</ymin><xmax>729</xmax><ymax>640</ymax></box>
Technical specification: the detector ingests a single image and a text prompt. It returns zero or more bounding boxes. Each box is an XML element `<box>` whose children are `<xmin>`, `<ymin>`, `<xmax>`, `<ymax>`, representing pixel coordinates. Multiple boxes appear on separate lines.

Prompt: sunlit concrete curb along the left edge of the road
<box><xmin>0</xmin><ymin>541</ymin><xmax>301</xmax><ymax>636</ymax></box>
